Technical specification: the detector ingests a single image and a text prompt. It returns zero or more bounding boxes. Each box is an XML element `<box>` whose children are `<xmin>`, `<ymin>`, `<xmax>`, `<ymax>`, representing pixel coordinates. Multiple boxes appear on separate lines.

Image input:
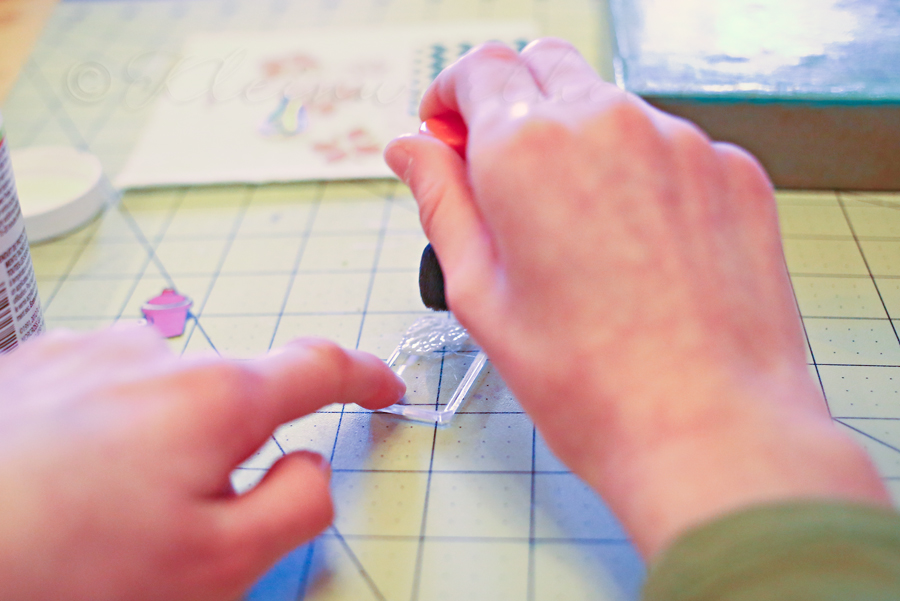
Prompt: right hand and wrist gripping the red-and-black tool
<box><xmin>385</xmin><ymin>39</ymin><xmax>886</xmax><ymax>556</ymax></box>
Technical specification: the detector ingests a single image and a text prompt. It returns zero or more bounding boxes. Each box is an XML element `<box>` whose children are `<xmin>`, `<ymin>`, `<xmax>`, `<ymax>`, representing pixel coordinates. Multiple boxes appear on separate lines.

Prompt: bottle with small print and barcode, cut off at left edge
<box><xmin>0</xmin><ymin>115</ymin><xmax>44</xmax><ymax>353</ymax></box>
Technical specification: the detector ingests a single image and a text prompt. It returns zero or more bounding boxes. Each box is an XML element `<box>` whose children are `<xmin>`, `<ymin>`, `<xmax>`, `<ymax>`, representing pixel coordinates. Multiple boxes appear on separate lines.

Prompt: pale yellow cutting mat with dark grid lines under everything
<box><xmin>2</xmin><ymin>0</ymin><xmax>900</xmax><ymax>601</ymax></box>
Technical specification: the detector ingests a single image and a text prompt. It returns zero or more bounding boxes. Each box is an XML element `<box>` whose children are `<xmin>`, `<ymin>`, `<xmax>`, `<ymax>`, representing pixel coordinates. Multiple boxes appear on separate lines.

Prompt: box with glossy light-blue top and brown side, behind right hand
<box><xmin>610</xmin><ymin>0</ymin><xmax>900</xmax><ymax>190</ymax></box>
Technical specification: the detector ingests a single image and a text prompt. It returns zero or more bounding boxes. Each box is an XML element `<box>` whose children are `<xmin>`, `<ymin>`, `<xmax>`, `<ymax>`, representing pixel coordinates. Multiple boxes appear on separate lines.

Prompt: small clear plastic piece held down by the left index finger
<box><xmin>381</xmin><ymin>312</ymin><xmax>487</xmax><ymax>425</ymax></box>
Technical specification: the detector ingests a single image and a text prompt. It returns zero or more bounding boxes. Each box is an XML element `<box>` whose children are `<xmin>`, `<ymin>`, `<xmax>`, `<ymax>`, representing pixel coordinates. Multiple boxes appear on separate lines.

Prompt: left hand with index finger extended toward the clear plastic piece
<box><xmin>0</xmin><ymin>327</ymin><xmax>403</xmax><ymax>601</ymax></box>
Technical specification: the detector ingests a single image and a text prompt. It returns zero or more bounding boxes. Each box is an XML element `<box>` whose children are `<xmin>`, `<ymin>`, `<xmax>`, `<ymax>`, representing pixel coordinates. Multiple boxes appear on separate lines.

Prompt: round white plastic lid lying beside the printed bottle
<box><xmin>10</xmin><ymin>146</ymin><xmax>110</xmax><ymax>242</ymax></box>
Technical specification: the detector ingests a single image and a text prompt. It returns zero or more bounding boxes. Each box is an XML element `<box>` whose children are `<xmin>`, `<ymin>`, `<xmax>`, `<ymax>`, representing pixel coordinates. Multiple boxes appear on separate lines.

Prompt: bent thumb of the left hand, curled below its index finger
<box><xmin>224</xmin><ymin>451</ymin><xmax>334</xmax><ymax>576</ymax></box>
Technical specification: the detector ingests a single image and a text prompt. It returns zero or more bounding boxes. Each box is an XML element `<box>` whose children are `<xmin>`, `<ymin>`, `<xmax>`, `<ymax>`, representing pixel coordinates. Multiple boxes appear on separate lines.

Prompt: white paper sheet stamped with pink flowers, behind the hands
<box><xmin>116</xmin><ymin>22</ymin><xmax>535</xmax><ymax>189</ymax></box>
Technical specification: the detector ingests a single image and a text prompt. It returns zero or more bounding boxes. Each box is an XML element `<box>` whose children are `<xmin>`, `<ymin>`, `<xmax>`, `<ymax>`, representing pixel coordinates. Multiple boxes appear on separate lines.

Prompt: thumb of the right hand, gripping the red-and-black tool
<box><xmin>384</xmin><ymin>135</ymin><xmax>494</xmax><ymax>317</ymax></box>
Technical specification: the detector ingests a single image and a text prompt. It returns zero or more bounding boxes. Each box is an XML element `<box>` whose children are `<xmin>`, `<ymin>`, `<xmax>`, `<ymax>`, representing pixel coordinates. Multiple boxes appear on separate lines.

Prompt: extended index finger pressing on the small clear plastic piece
<box><xmin>165</xmin><ymin>338</ymin><xmax>406</xmax><ymax>494</ymax></box>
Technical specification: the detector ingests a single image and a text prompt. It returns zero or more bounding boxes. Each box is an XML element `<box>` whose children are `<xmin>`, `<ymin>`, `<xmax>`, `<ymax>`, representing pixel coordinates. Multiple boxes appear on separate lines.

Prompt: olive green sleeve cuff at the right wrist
<box><xmin>643</xmin><ymin>502</ymin><xmax>900</xmax><ymax>601</ymax></box>
